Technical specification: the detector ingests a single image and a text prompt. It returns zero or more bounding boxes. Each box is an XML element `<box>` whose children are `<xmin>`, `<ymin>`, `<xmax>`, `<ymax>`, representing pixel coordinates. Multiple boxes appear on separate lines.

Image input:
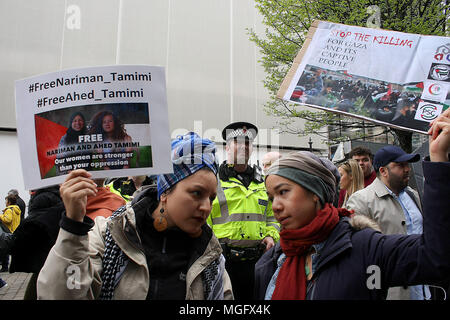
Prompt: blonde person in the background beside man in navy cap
<box><xmin>338</xmin><ymin>159</ymin><xmax>364</xmax><ymax>207</ymax></box>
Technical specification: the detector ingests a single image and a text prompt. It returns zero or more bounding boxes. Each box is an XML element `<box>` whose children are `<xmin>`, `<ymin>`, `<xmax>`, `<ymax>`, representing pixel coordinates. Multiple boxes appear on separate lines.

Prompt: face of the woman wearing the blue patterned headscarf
<box><xmin>161</xmin><ymin>169</ymin><xmax>217</xmax><ymax>237</ymax></box>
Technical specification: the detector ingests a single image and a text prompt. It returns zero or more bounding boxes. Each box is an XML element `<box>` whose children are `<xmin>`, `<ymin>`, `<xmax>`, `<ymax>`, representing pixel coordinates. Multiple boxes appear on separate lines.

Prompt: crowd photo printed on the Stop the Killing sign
<box><xmin>291</xmin><ymin>67</ymin><xmax>427</xmax><ymax>131</ymax></box>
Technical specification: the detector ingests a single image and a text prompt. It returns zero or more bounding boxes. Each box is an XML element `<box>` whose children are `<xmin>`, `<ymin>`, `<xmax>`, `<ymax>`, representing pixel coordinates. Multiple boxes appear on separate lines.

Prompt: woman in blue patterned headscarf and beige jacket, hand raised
<box><xmin>37</xmin><ymin>132</ymin><xmax>233</xmax><ymax>300</ymax></box>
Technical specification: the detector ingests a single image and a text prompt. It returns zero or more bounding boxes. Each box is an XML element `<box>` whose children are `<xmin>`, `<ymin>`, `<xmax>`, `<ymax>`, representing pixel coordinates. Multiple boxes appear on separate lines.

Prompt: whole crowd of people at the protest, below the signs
<box><xmin>0</xmin><ymin>109</ymin><xmax>450</xmax><ymax>301</ymax></box>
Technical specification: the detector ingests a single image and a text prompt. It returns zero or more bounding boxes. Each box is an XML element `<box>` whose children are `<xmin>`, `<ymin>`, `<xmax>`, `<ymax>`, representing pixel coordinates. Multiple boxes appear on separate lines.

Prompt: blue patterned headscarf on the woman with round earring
<box><xmin>157</xmin><ymin>132</ymin><xmax>219</xmax><ymax>199</ymax></box>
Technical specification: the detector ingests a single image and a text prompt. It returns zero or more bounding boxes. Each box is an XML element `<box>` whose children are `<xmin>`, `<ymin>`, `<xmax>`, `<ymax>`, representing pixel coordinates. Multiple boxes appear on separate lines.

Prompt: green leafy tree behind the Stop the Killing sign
<box><xmin>248</xmin><ymin>0</ymin><xmax>450</xmax><ymax>152</ymax></box>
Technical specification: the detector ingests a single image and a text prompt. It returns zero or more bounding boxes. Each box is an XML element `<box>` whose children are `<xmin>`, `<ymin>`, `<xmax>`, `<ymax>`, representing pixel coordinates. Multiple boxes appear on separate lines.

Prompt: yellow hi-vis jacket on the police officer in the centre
<box><xmin>207</xmin><ymin>177</ymin><xmax>280</xmax><ymax>247</ymax></box>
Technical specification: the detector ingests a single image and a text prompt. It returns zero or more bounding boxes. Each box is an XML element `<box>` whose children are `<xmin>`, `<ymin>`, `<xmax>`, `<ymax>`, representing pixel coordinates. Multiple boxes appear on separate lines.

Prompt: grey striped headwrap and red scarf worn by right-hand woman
<box><xmin>267</xmin><ymin>151</ymin><xmax>352</xmax><ymax>300</ymax></box>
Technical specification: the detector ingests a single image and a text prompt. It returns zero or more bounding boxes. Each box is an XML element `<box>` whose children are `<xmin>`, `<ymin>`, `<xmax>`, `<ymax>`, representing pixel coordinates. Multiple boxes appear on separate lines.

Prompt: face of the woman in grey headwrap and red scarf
<box><xmin>266</xmin><ymin>175</ymin><xmax>320</xmax><ymax>229</ymax></box>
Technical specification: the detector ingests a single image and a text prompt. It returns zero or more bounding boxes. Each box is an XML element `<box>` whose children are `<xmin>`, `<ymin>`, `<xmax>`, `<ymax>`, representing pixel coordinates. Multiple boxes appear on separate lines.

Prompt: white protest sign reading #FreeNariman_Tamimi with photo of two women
<box><xmin>16</xmin><ymin>65</ymin><xmax>172</xmax><ymax>189</ymax></box>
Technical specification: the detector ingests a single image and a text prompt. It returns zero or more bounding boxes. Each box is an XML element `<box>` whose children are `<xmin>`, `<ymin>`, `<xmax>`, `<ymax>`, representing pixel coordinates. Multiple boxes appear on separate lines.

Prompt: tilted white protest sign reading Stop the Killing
<box><xmin>277</xmin><ymin>21</ymin><xmax>450</xmax><ymax>133</ymax></box>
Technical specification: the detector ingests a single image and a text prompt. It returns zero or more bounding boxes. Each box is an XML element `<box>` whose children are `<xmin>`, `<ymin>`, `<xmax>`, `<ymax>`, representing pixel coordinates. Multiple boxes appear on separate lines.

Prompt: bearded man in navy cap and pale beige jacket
<box><xmin>346</xmin><ymin>146</ymin><xmax>430</xmax><ymax>300</ymax></box>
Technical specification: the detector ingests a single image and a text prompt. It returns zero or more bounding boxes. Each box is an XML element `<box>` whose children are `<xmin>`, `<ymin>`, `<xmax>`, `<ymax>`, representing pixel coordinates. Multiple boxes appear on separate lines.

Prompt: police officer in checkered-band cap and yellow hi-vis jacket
<box><xmin>207</xmin><ymin>122</ymin><xmax>280</xmax><ymax>300</ymax></box>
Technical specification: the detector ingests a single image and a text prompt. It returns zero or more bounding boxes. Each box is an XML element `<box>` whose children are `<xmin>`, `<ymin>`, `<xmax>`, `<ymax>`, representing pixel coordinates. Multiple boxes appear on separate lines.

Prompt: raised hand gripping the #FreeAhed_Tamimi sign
<box><xmin>59</xmin><ymin>169</ymin><xmax>97</xmax><ymax>222</ymax></box>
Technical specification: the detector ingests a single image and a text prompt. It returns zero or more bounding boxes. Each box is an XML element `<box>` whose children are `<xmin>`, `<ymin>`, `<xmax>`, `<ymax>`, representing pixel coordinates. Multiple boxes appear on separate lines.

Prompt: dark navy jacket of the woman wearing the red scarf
<box><xmin>255</xmin><ymin>161</ymin><xmax>450</xmax><ymax>300</ymax></box>
